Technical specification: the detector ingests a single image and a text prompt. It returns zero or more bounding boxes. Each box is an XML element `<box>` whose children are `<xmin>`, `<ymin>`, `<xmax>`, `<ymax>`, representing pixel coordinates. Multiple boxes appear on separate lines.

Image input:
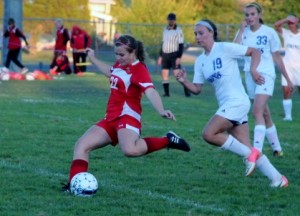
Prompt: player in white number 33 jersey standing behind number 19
<box><xmin>234</xmin><ymin>3</ymin><xmax>293</xmax><ymax>156</ymax></box>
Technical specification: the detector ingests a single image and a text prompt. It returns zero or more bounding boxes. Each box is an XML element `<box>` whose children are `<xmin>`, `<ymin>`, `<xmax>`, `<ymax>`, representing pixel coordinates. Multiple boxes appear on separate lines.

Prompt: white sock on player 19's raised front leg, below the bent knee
<box><xmin>221</xmin><ymin>135</ymin><xmax>251</xmax><ymax>157</ymax></box>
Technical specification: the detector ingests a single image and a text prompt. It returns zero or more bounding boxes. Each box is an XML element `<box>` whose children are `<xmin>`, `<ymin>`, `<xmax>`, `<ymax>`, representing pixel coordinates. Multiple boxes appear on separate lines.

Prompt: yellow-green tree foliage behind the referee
<box><xmin>112</xmin><ymin>0</ymin><xmax>198</xmax><ymax>58</ymax></box>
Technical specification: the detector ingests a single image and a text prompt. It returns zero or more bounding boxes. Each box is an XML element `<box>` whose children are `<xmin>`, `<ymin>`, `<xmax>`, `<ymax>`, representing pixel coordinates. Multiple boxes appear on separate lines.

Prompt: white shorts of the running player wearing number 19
<box><xmin>216</xmin><ymin>103</ymin><xmax>250</xmax><ymax>125</ymax></box>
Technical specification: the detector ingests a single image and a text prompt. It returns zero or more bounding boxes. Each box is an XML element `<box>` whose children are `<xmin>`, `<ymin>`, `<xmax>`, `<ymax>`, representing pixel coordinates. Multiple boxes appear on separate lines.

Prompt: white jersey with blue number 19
<box><xmin>193</xmin><ymin>42</ymin><xmax>250</xmax><ymax>107</ymax></box>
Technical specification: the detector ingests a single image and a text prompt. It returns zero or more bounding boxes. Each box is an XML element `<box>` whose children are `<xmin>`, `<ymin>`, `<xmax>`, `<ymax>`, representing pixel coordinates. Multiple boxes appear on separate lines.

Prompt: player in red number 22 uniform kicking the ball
<box><xmin>63</xmin><ymin>35</ymin><xmax>190</xmax><ymax>191</ymax></box>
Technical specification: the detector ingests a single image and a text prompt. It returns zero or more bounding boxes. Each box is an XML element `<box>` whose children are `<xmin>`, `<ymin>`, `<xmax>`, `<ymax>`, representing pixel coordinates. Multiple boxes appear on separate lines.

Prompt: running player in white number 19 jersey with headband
<box><xmin>177</xmin><ymin>19</ymin><xmax>288</xmax><ymax>187</ymax></box>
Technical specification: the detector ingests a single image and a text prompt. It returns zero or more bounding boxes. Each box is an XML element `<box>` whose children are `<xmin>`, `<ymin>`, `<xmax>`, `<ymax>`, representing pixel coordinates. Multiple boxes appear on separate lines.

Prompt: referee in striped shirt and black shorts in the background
<box><xmin>157</xmin><ymin>13</ymin><xmax>190</xmax><ymax>97</ymax></box>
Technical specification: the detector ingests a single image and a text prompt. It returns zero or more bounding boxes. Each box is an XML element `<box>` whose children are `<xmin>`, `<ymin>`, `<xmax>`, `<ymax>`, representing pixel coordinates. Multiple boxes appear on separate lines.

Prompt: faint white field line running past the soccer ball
<box><xmin>0</xmin><ymin>159</ymin><xmax>224</xmax><ymax>212</ymax></box>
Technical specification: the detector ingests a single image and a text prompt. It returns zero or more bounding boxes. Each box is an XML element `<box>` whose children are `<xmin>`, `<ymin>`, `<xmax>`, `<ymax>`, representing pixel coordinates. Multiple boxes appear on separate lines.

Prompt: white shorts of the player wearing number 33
<box><xmin>245</xmin><ymin>72</ymin><xmax>275</xmax><ymax>99</ymax></box>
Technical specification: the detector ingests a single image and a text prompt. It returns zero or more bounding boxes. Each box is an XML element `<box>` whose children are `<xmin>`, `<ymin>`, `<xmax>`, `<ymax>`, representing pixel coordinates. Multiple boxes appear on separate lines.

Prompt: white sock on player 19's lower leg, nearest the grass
<box><xmin>256</xmin><ymin>155</ymin><xmax>282</xmax><ymax>182</ymax></box>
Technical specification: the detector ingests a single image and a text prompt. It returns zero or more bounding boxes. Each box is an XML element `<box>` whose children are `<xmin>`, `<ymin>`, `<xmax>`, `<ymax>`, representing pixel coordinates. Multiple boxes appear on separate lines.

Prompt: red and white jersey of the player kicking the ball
<box><xmin>105</xmin><ymin>60</ymin><xmax>154</xmax><ymax>121</ymax></box>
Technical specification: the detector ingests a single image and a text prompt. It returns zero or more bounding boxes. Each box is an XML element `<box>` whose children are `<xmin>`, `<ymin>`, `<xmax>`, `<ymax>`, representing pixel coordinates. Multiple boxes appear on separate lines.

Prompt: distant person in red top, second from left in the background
<box><xmin>50</xmin><ymin>19</ymin><xmax>70</xmax><ymax>69</ymax></box>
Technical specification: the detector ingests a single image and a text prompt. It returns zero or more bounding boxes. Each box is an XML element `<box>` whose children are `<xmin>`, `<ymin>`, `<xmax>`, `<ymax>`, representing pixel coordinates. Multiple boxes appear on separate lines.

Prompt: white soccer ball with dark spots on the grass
<box><xmin>70</xmin><ymin>172</ymin><xmax>98</xmax><ymax>197</ymax></box>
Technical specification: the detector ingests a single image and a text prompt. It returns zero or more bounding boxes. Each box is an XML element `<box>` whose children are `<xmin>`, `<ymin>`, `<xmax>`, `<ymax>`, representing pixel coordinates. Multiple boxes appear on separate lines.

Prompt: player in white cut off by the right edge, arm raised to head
<box><xmin>274</xmin><ymin>15</ymin><xmax>300</xmax><ymax>121</ymax></box>
